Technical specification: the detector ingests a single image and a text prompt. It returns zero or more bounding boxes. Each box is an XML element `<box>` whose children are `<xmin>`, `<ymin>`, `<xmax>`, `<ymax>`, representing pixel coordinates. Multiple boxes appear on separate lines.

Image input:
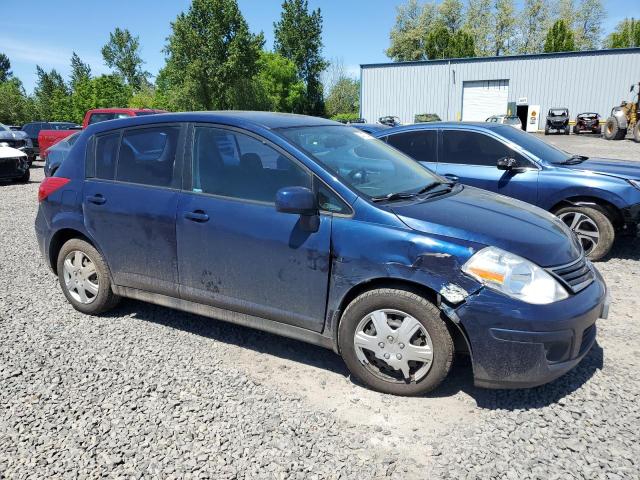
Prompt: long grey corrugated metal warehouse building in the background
<box><xmin>360</xmin><ymin>48</ymin><xmax>640</xmax><ymax>131</ymax></box>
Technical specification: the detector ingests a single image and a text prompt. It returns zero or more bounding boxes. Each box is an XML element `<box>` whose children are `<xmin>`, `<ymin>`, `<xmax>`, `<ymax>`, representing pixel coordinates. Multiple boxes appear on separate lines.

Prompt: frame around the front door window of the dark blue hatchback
<box><xmin>182</xmin><ymin>122</ymin><xmax>355</xmax><ymax>217</ymax></box>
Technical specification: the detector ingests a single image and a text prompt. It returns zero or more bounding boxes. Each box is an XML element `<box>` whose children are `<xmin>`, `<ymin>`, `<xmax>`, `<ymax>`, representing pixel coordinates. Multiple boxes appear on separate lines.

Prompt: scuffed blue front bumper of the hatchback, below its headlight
<box><xmin>443</xmin><ymin>271</ymin><xmax>609</xmax><ymax>388</ymax></box>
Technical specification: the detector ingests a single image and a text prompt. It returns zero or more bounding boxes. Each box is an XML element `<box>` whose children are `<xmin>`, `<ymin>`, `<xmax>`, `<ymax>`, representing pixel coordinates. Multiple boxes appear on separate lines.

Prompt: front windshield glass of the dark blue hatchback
<box><xmin>279</xmin><ymin>126</ymin><xmax>442</xmax><ymax>198</ymax></box>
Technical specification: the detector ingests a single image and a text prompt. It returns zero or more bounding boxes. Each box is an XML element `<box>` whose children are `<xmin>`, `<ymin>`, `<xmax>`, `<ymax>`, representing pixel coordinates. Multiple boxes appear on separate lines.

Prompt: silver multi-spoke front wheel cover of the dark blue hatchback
<box><xmin>353</xmin><ymin>309</ymin><xmax>433</xmax><ymax>383</ymax></box>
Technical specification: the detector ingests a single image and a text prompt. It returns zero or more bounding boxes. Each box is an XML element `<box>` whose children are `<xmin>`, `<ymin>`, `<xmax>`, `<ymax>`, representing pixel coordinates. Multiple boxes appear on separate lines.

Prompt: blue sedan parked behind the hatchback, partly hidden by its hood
<box><xmin>375</xmin><ymin>122</ymin><xmax>640</xmax><ymax>260</ymax></box>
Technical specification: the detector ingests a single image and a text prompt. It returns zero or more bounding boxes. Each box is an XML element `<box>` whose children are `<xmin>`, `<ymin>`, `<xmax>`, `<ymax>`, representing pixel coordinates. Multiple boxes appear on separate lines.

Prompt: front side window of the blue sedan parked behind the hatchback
<box><xmin>440</xmin><ymin>130</ymin><xmax>530</xmax><ymax>167</ymax></box>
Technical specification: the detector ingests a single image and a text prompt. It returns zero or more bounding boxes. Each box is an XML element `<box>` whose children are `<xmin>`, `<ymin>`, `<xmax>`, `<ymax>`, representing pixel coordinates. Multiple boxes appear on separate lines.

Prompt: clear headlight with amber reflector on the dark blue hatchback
<box><xmin>462</xmin><ymin>247</ymin><xmax>569</xmax><ymax>305</ymax></box>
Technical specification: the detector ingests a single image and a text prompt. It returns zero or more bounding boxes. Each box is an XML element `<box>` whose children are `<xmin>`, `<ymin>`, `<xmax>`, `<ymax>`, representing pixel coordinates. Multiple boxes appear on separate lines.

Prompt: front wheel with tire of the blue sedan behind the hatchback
<box><xmin>554</xmin><ymin>205</ymin><xmax>616</xmax><ymax>260</ymax></box>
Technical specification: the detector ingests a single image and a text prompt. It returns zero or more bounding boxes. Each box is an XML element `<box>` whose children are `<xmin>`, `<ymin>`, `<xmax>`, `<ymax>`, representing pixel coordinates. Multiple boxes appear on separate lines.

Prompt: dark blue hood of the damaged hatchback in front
<box><xmin>391</xmin><ymin>186</ymin><xmax>582</xmax><ymax>267</ymax></box>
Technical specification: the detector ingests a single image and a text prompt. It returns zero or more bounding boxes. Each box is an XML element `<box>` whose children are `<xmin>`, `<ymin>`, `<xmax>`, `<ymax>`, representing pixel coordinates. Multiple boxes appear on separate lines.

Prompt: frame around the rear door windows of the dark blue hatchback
<box><xmin>85</xmin><ymin>122</ymin><xmax>188</xmax><ymax>191</ymax></box>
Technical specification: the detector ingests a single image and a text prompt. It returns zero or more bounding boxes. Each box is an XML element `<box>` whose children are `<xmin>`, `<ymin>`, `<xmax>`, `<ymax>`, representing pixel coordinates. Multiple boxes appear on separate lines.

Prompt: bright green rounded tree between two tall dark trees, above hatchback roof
<box><xmin>254</xmin><ymin>52</ymin><xmax>305</xmax><ymax>112</ymax></box>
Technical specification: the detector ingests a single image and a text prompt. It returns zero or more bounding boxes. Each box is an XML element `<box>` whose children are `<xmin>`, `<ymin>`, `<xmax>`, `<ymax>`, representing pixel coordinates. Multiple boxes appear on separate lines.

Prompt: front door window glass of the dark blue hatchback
<box><xmin>192</xmin><ymin>127</ymin><xmax>311</xmax><ymax>202</ymax></box>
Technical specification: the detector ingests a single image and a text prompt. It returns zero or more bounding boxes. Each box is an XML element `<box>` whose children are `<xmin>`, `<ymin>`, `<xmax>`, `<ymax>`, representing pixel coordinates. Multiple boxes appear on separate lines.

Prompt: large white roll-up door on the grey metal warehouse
<box><xmin>462</xmin><ymin>80</ymin><xmax>509</xmax><ymax>122</ymax></box>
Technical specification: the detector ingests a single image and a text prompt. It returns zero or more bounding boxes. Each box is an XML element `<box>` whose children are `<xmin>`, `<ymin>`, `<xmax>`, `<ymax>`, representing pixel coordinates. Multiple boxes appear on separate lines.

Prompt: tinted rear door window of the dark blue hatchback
<box><xmin>116</xmin><ymin>126</ymin><xmax>180</xmax><ymax>187</ymax></box>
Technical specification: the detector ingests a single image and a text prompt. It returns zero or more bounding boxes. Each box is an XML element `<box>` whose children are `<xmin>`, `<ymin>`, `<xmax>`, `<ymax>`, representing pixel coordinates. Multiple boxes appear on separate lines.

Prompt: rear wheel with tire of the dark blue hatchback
<box><xmin>57</xmin><ymin>238</ymin><xmax>120</xmax><ymax>315</ymax></box>
